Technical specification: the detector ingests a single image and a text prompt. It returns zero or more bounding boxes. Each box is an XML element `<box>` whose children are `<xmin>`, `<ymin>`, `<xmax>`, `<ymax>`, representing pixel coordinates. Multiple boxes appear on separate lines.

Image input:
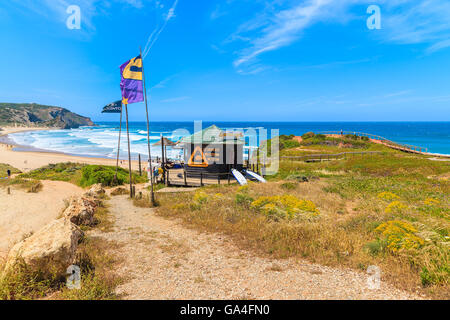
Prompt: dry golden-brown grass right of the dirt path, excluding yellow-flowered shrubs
<box><xmin>158</xmin><ymin>170</ymin><xmax>449</xmax><ymax>298</ymax></box>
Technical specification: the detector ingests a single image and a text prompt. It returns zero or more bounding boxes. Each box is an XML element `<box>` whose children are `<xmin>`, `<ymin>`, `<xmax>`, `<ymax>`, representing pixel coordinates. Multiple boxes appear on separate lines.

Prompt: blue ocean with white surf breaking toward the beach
<box><xmin>9</xmin><ymin>122</ymin><xmax>450</xmax><ymax>159</ymax></box>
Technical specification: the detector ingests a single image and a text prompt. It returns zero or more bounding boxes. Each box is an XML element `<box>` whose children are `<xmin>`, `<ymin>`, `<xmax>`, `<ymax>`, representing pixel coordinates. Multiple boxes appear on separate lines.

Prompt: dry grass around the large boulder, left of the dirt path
<box><xmin>0</xmin><ymin>198</ymin><xmax>122</xmax><ymax>300</ymax></box>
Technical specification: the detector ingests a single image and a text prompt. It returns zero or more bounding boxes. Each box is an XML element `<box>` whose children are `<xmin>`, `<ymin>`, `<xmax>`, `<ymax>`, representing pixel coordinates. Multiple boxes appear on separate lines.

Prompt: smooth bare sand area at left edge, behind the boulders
<box><xmin>0</xmin><ymin>181</ymin><xmax>83</xmax><ymax>258</ymax></box>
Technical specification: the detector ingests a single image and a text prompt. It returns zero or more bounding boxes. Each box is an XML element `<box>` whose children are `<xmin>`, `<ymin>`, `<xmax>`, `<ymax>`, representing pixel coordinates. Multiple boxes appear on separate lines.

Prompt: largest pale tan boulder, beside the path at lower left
<box><xmin>5</xmin><ymin>218</ymin><xmax>83</xmax><ymax>277</ymax></box>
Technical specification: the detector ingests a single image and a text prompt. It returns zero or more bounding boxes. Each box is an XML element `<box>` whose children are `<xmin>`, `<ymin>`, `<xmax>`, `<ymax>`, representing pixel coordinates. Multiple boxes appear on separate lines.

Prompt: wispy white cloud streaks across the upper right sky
<box><xmin>229</xmin><ymin>0</ymin><xmax>450</xmax><ymax>68</ymax></box>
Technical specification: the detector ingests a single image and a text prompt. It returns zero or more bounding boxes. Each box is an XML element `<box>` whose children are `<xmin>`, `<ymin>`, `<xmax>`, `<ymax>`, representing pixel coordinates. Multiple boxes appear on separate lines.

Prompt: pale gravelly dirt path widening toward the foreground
<box><xmin>96</xmin><ymin>196</ymin><xmax>424</xmax><ymax>299</ymax></box>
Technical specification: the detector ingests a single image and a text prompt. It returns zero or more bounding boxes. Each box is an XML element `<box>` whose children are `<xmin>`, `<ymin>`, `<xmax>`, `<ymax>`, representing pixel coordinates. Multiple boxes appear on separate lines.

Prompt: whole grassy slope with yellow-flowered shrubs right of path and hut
<box><xmin>158</xmin><ymin>134</ymin><xmax>450</xmax><ymax>299</ymax></box>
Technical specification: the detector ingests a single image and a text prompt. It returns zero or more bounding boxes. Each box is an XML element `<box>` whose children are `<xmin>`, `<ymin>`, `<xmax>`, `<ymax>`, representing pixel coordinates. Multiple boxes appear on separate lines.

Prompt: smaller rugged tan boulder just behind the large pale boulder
<box><xmin>63</xmin><ymin>197</ymin><xmax>98</xmax><ymax>226</ymax></box>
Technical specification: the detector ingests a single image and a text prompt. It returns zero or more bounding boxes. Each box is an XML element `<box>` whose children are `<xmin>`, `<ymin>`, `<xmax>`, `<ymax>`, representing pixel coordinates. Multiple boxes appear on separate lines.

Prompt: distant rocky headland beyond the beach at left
<box><xmin>0</xmin><ymin>103</ymin><xmax>94</xmax><ymax>129</ymax></box>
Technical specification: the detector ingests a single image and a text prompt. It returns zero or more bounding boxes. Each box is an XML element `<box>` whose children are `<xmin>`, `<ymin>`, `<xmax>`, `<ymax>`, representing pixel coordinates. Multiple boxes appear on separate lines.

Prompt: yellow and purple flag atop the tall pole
<box><xmin>120</xmin><ymin>55</ymin><xmax>144</xmax><ymax>104</ymax></box>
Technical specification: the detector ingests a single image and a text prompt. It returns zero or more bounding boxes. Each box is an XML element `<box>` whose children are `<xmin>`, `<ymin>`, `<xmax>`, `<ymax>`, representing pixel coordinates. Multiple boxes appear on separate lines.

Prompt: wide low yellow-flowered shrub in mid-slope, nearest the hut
<box><xmin>251</xmin><ymin>195</ymin><xmax>320</xmax><ymax>219</ymax></box>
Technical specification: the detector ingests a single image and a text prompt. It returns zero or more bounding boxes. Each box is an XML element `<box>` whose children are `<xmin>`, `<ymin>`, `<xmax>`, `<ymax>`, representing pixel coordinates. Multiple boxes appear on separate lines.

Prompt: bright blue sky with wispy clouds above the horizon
<box><xmin>0</xmin><ymin>0</ymin><xmax>450</xmax><ymax>121</ymax></box>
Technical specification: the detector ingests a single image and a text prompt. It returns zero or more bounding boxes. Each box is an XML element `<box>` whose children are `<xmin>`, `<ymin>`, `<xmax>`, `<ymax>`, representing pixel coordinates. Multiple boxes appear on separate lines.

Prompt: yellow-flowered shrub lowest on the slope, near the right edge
<box><xmin>375</xmin><ymin>220</ymin><xmax>425</xmax><ymax>252</ymax></box>
